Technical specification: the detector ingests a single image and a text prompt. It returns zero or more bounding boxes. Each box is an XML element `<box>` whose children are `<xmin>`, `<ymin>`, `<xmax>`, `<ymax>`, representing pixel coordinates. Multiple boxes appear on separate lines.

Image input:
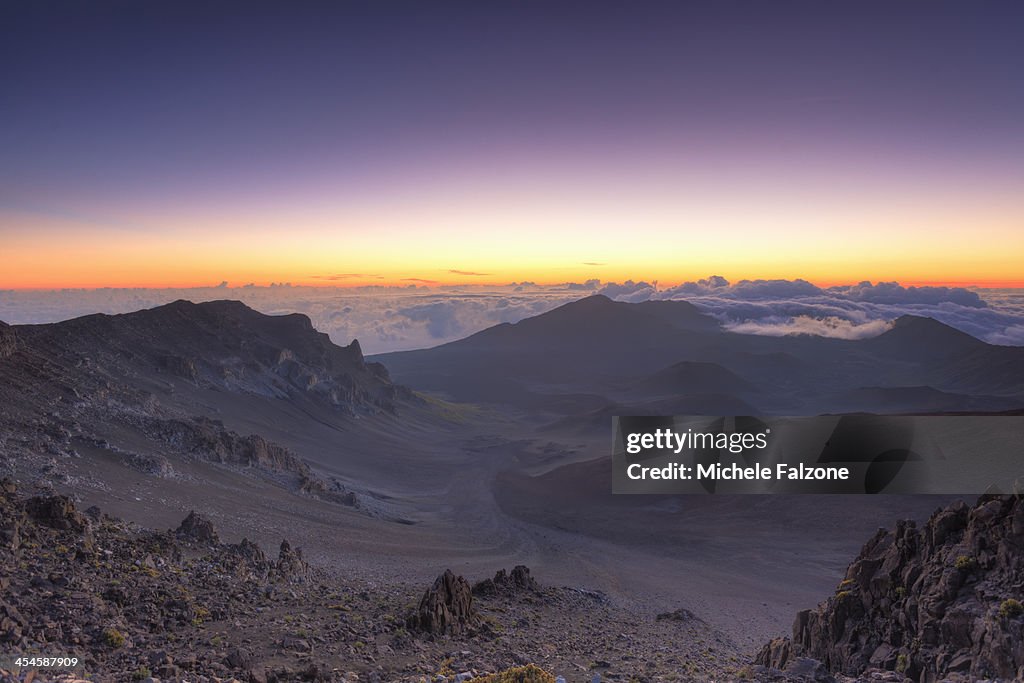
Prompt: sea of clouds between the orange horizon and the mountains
<box><xmin>0</xmin><ymin>275</ymin><xmax>1024</xmax><ymax>354</ymax></box>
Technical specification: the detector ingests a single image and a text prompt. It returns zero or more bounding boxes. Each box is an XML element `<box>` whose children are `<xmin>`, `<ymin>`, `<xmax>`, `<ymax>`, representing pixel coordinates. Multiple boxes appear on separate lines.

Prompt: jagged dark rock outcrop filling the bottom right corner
<box><xmin>757</xmin><ymin>497</ymin><xmax>1024</xmax><ymax>682</ymax></box>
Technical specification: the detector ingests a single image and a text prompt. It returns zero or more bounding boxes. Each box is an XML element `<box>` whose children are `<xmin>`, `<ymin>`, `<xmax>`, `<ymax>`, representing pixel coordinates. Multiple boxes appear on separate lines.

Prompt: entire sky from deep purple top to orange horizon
<box><xmin>0</xmin><ymin>0</ymin><xmax>1024</xmax><ymax>290</ymax></box>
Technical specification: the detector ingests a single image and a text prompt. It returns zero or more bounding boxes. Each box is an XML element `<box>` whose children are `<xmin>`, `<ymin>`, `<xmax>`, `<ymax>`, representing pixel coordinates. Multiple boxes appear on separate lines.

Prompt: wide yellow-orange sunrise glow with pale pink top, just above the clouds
<box><xmin>0</xmin><ymin>187</ymin><xmax>1024</xmax><ymax>290</ymax></box>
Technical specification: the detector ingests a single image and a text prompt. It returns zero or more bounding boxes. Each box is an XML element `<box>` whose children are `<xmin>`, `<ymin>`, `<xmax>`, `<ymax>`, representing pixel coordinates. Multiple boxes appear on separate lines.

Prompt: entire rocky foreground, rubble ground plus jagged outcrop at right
<box><xmin>0</xmin><ymin>473</ymin><xmax>1024</xmax><ymax>683</ymax></box>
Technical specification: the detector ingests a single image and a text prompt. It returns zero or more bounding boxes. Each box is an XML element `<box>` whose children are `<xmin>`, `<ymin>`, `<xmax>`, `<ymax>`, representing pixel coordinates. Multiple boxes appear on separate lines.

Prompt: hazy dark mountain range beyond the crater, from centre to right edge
<box><xmin>380</xmin><ymin>296</ymin><xmax>1024</xmax><ymax>417</ymax></box>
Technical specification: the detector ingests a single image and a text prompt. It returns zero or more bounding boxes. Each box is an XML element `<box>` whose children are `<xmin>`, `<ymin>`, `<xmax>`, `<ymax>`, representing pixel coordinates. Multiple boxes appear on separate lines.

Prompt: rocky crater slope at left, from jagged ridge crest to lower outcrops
<box><xmin>0</xmin><ymin>301</ymin><xmax>417</xmax><ymax>505</ymax></box>
